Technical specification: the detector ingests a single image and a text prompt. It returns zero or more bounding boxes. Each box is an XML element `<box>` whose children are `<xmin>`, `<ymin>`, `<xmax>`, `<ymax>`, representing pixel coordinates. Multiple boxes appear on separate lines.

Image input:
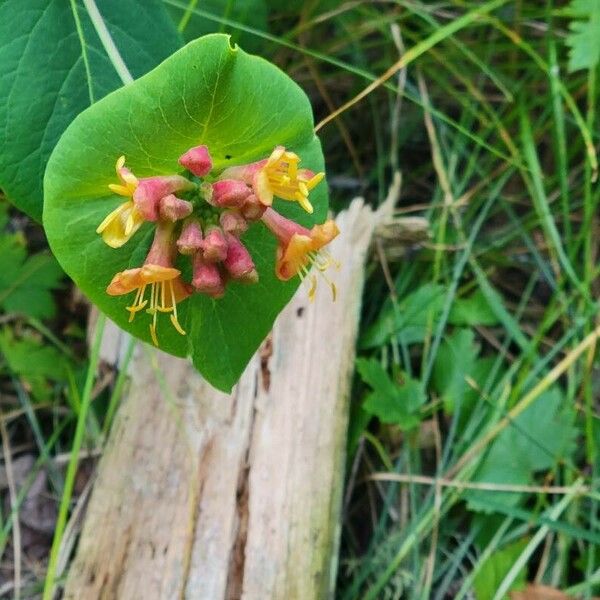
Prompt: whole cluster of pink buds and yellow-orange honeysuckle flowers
<box><xmin>96</xmin><ymin>146</ymin><xmax>339</xmax><ymax>346</ymax></box>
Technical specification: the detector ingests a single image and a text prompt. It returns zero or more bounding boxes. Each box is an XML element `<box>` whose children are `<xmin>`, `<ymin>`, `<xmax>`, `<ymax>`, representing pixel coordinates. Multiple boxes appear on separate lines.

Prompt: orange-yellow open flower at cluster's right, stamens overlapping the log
<box><xmin>262</xmin><ymin>208</ymin><xmax>339</xmax><ymax>300</ymax></box>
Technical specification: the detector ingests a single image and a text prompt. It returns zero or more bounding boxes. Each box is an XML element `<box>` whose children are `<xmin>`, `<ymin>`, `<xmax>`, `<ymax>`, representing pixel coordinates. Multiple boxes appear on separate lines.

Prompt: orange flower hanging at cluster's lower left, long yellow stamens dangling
<box><xmin>106</xmin><ymin>222</ymin><xmax>191</xmax><ymax>346</ymax></box>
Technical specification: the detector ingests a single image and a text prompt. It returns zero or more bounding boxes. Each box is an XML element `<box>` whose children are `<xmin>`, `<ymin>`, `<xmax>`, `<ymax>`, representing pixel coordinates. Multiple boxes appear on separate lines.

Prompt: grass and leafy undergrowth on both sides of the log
<box><xmin>0</xmin><ymin>0</ymin><xmax>600</xmax><ymax>599</ymax></box>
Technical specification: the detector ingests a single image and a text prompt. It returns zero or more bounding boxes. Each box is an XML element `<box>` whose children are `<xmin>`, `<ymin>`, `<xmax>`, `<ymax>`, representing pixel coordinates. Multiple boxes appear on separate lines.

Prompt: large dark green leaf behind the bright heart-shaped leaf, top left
<box><xmin>0</xmin><ymin>0</ymin><xmax>181</xmax><ymax>221</ymax></box>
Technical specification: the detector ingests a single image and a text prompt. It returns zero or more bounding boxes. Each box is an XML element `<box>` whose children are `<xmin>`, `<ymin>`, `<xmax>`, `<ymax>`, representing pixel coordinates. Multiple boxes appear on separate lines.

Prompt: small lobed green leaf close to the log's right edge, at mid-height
<box><xmin>356</xmin><ymin>358</ymin><xmax>426</xmax><ymax>430</ymax></box>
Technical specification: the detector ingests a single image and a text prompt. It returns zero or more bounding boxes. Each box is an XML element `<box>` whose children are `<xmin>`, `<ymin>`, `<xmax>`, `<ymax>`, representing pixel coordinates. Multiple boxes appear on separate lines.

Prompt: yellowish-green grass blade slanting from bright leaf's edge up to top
<box><xmin>315</xmin><ymin>0</ymin><xmax>508</xmax><ymax>131</ymax></box>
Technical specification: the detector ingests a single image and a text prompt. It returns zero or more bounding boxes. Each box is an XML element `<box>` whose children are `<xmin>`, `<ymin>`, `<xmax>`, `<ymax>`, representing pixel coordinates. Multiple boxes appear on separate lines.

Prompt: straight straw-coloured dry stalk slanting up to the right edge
<box><xmin>446</xmin><ymin>326</ymin><xmax>600</xmax><ymax>478</ymax></box>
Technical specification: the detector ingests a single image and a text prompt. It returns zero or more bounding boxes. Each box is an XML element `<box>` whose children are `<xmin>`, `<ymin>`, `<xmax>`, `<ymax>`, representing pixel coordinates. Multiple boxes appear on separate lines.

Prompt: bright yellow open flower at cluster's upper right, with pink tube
<box><xmin>220</xmin><ymin>146</ymin><xmax>325</xmax><ymax>213</ymax></box>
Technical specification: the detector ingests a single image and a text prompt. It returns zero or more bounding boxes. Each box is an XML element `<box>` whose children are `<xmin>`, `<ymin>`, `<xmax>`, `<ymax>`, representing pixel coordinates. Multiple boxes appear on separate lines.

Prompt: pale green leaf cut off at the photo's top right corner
<box><xmin>565</xmin><ymin>0</ymin><xmax>600</xmax><ymax>72</ymax></box>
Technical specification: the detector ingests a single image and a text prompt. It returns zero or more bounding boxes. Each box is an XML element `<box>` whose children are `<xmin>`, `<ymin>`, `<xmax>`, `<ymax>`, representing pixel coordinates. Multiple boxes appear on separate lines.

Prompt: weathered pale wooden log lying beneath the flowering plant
<box><xmin>65</xmin><ymin>195</ymin><xmax>389</xmax><ymax>600</ymax></box>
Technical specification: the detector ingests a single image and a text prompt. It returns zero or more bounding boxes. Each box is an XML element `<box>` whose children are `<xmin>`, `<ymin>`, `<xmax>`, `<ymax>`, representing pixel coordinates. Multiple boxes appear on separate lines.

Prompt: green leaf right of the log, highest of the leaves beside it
<box><xmin>360</xmin><ymin>283</ymin><xmax>444</xmax><ymax>349</ymax></box>
